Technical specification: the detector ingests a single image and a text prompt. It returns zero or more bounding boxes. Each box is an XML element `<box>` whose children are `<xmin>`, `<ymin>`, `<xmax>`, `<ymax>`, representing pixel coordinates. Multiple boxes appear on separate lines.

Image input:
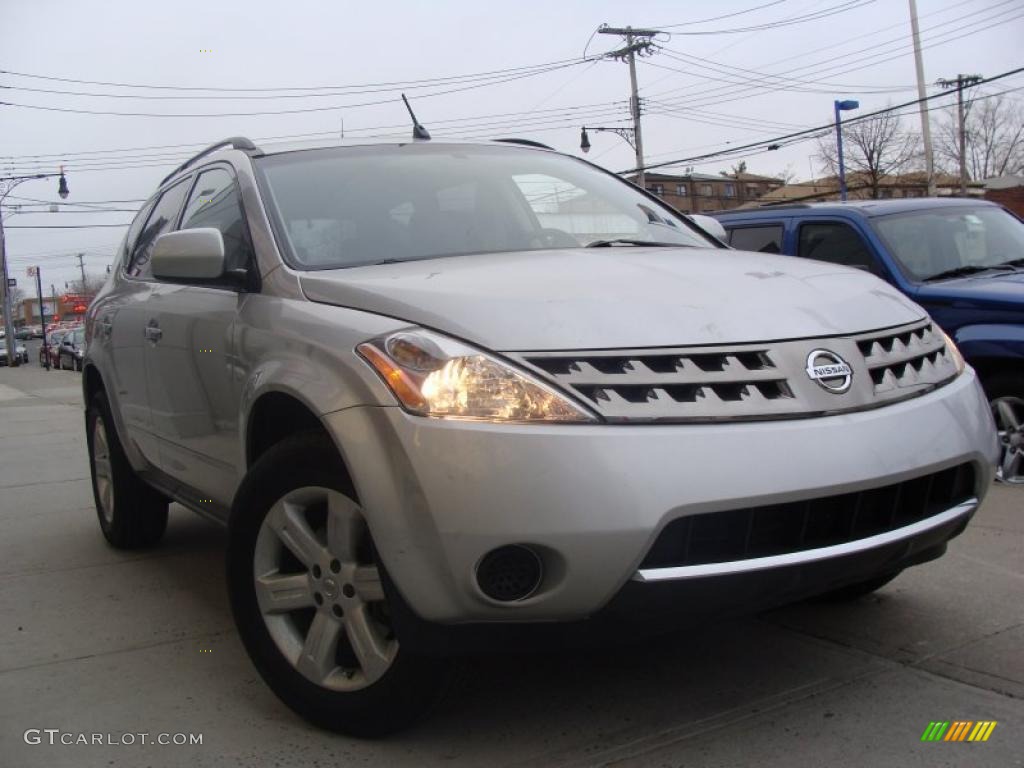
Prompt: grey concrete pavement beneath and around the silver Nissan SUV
<box><xmin>0</xmin><ymin>362</ymin><xmax>1024</xmax><ymax>768</ymax></box>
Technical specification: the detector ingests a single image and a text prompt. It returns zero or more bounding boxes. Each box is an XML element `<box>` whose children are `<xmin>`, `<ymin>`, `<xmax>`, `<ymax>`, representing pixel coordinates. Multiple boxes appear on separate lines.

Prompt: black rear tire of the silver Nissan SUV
<box><xmin>86</xmin><ymin>390</ymin><xmax>168</xmax><ymax>549</ymax></box>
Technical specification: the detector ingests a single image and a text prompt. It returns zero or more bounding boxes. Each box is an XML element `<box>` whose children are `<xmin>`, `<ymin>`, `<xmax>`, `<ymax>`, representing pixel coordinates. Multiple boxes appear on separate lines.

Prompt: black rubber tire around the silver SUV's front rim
<box><xmin>227</xmin><ymin>432</ymin><xmax>452</xmax><ymax>737</ymax></box>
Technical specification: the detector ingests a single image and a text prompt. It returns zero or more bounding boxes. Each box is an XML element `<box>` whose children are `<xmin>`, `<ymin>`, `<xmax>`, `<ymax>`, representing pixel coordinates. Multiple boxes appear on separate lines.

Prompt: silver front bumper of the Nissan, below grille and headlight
<box><xmin>324</xmin><ymin>370</ymin><xmax>996</xmax><ymax>624</ymax></box>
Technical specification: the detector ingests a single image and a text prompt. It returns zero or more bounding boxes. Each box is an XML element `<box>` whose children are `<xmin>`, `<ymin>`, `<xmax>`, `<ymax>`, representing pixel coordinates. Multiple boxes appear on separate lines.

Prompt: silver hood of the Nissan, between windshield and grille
<box><xmin>300</xmin><ymin>247</ymin><xmax>925</xmax><ymax>351</ymax></box>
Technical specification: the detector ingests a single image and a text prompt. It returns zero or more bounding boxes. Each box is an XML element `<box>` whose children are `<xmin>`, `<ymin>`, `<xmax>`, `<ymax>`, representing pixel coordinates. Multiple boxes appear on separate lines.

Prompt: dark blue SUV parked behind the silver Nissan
<box><xmin>716</xmin><ymin>198</ymin><xmax>1024</xmax><ymax>483</ymax></box>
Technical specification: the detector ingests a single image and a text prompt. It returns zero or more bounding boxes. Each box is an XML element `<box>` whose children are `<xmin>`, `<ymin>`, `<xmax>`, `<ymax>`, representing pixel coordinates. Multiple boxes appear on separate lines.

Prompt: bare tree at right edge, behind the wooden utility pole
<box><xmin>935</xmin><ymin>95</ymin><xmax>1024</xmax><ymax>180</ymax></box>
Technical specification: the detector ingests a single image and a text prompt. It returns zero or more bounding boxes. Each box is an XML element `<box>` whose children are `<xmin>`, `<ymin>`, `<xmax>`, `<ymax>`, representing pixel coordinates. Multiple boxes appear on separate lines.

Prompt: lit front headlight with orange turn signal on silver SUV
<box><xmin>356</xmin><ymin>330</ymin><xmax>596</xmax><ymax>422</ymax></box>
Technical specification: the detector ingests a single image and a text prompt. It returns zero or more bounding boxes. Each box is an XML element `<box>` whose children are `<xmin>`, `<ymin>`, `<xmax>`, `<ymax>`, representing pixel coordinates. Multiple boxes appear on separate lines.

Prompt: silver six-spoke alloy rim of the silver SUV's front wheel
<box><xmin>253</xmin><ymin>487</ymin><xmax>398</xmax><ymax>691</ymax></box>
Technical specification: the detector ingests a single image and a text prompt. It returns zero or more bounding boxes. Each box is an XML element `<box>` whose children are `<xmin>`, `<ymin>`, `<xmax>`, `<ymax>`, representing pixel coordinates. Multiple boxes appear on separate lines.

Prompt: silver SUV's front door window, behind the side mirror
<box><xmin>181</xmin><ymin>168</ymin><xmax>253</xmax><ymax>270</ymax></box>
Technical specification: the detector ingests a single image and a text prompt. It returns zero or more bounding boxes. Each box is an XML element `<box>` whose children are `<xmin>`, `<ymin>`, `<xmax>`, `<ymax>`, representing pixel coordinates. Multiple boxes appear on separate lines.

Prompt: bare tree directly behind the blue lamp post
<box><xmin>816</xmin><ymin>112</ymin><xmax>921</xmax><ymax>199</ymax></box>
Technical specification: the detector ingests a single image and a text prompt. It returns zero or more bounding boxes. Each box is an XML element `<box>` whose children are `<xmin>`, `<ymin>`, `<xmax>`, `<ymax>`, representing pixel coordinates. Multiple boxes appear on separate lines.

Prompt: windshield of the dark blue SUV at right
<box><xmin>871</xmin><ymin>206</ymin><xmax>1024</xmax><ymax>281</ymax></box>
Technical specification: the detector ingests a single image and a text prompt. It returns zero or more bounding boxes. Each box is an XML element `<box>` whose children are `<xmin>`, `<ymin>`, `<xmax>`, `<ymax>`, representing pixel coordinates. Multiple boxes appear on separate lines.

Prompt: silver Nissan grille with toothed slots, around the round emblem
<box><xmin>509</xmin><ymin>322</ymin><xmax>955</xmax><ymax>422</ymax></box>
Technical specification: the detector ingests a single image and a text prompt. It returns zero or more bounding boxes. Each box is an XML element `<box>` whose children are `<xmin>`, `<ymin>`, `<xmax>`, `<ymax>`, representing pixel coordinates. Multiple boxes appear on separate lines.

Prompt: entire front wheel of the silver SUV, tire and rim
<box><xmin>227</xmin><ymin>433</ymin><xmax>451</xmax><ymax>736</ymax></box>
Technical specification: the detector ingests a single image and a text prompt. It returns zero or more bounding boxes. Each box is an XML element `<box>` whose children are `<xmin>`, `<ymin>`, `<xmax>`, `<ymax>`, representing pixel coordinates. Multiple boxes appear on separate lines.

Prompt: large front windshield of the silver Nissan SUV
<box><xmin>257</xmin><ymin>144</ymin><xmax>714</xmax><ymax>269</ymax></box>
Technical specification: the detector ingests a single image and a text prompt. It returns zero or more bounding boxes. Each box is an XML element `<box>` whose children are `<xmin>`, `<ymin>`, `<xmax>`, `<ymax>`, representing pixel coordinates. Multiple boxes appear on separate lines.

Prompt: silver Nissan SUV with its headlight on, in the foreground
<box><xmin>83</xmin><ymin>138</ymin><xmax>996</xmax><ymax>735</ymax></box>
